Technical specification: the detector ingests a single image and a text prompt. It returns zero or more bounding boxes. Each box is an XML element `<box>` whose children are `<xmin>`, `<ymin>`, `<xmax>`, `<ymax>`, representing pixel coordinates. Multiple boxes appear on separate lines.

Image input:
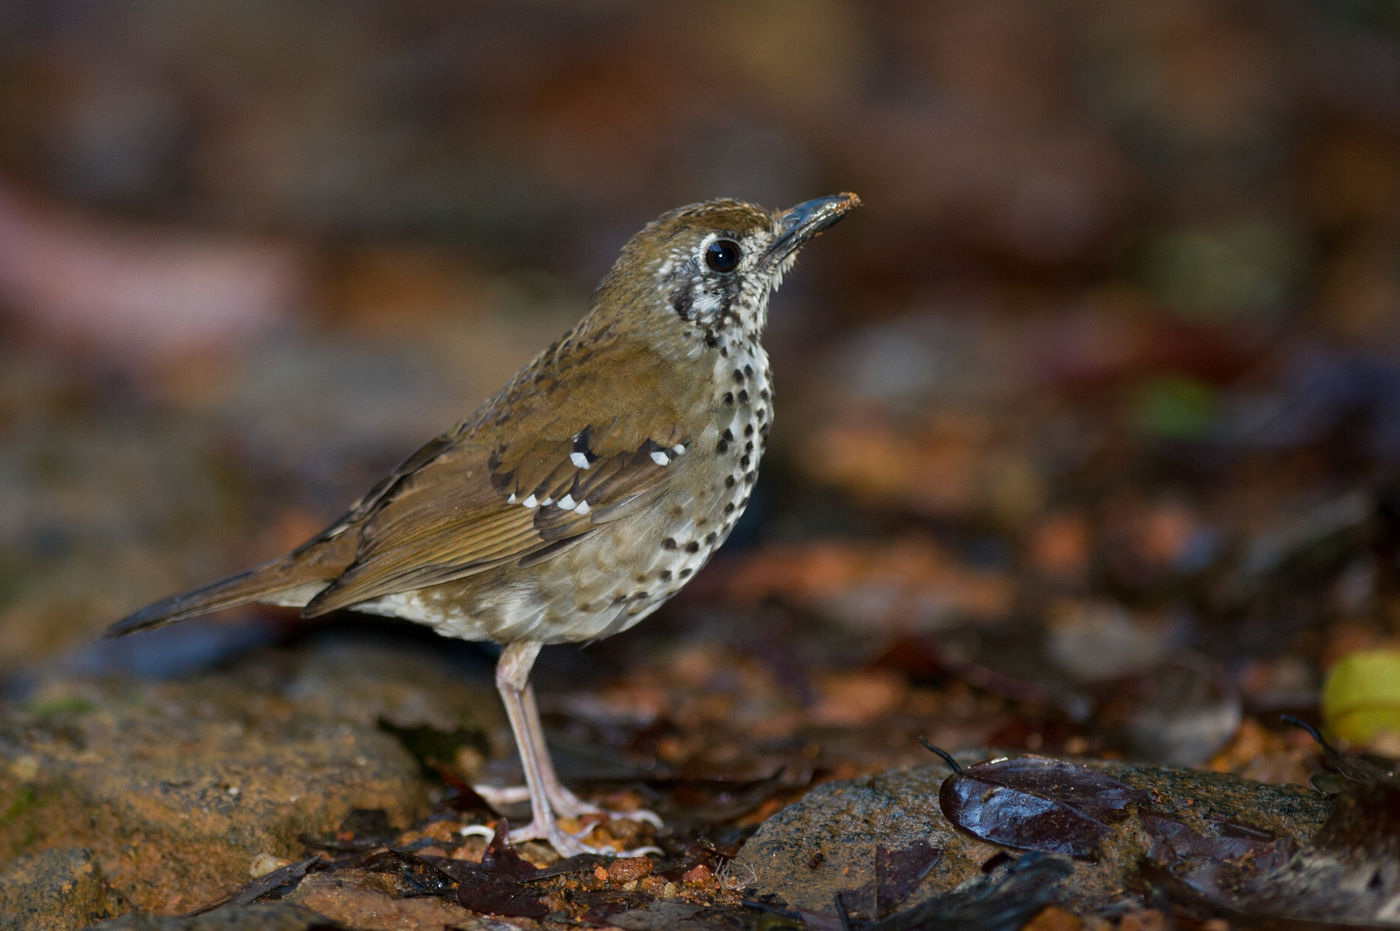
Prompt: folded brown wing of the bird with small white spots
<box><xmin>304</xmin><ymin>420</ymin><xmax>685</xmax><ymax>616</ymax></box>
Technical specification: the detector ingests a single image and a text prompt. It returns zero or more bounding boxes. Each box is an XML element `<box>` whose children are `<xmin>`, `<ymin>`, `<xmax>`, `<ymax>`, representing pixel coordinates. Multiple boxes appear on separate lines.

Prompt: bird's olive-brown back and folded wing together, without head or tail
<box><xmin>305</xmin><ymin>330</ymin><xmax>706</xmax><ymax>615</ymax></box>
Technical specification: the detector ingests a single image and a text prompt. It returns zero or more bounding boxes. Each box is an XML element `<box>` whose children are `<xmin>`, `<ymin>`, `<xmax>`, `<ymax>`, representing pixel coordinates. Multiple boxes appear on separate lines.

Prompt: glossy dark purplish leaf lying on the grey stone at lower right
<box><xmin>938</xmin><ymin>756</ymin><xmax>1149</xmax><ymax>860</ymax></box>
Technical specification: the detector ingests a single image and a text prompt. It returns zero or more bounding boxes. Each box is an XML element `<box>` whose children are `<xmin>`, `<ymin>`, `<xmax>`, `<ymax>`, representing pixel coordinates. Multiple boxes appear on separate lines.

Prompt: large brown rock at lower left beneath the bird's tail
<box><xmin>0</xmin><ymin>634</ymin><xmax>497</xmax><ymax>927</ymax></box>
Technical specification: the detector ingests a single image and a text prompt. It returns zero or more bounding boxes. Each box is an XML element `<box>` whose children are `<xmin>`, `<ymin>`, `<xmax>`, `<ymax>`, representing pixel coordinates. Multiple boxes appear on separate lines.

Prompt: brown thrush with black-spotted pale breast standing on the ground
<box><xmin>106</xmin><ymin>195</ymin><xmax>860</xmax><ymax>855</ymax></box>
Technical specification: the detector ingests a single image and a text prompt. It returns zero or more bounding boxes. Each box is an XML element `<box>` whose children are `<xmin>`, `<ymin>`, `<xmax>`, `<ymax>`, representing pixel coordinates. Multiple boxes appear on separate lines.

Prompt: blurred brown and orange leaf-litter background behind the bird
<box><xmin>0</xmin><ymin>0</ymin><xmax>1400</xmax><ymax>756</ymax></box>
